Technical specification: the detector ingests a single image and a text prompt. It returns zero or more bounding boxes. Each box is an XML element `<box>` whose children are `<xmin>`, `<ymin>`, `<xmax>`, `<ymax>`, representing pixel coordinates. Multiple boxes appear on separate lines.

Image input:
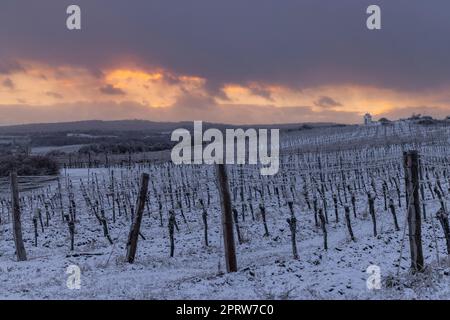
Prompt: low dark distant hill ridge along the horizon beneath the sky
<box><xmin>0</xmin><ymin>120</ymin><xmax>336</xmax><ymax>135</ymax></box>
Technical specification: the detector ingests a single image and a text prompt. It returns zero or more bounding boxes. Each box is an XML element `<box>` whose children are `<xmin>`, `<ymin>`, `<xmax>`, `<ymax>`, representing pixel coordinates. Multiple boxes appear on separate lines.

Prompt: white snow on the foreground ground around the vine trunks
<box><xmin>0</xmin><ymin>169</ymin><xmax>450</xmax><ymax>299</ymax></box>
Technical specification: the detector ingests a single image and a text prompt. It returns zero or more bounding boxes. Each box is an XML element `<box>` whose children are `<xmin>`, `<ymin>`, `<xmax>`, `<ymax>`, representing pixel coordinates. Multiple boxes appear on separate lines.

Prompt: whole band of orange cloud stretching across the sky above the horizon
<box><xmin>0</xmin><ymin>61</ymin><xmax>450</xmax><ymax>123</ymax></box>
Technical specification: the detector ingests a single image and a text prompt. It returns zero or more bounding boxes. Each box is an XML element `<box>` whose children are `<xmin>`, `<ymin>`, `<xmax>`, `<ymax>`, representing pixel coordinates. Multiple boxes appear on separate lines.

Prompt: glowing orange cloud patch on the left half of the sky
<box><xmin>0</xmin><ymin>62</ymin><xmax>205</xmax><ymax>107</ymax></box>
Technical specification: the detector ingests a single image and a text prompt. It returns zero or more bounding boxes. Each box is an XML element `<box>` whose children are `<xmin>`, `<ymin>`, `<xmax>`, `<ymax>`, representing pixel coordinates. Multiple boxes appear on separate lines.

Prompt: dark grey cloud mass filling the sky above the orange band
<box><xmin>0</xmin><ymin>0</ymin><xmax>450</xmax><ymax>95</ymax></box>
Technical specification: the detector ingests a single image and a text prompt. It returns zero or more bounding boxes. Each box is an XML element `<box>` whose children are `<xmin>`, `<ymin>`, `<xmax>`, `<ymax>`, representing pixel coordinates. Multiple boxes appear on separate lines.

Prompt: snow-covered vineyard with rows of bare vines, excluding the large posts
<box><xmin>0</xmin><ymin>122</ymin><xmax>450</xmax><ymax>299</ymax></box>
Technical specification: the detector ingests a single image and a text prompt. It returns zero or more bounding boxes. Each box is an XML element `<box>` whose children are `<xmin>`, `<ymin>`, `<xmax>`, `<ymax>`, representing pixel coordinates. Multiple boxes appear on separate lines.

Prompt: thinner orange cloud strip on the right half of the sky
<box><xmin>217</xmin><ymin>84</ymin><xmax>450</xmax><ymax>115</ymax></box>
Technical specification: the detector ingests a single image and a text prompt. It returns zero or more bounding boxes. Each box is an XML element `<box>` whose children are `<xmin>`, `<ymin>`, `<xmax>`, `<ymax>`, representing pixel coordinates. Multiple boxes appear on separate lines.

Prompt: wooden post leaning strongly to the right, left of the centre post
<box><xmin>127</xmin><ymin>173</ymin><xmax>149</xmax><ymax>263</ymax></box>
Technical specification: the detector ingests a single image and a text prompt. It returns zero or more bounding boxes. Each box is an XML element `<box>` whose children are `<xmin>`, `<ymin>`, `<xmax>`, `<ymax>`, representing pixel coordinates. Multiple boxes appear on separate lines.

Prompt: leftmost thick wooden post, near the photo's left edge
<box><xmin>10</xmin><ymin>171</ymin><xmax>27</xmax><ymax>261</ymax></box>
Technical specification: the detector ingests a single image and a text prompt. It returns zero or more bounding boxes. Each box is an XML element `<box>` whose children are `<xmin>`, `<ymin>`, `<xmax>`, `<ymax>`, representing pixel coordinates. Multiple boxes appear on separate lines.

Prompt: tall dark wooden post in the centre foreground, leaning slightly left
<box><xmin>216</xmin><ymin>164</ymin><xmax>237</xmax><ymax>272</ymax></box>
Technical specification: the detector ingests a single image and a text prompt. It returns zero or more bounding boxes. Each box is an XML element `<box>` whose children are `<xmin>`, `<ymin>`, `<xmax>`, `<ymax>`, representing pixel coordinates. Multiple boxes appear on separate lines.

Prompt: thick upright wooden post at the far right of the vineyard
<box><xmin>403</xmin><ymin>151</ymin><xmax>424</xmax><ymax>272</ymax></box>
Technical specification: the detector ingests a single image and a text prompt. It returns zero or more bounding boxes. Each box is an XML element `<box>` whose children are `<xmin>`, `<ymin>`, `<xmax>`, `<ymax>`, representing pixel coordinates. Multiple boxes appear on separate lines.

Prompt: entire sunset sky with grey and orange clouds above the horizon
<box><xmin>0</xmin><ymin>0</ymin><xmax>450</xmax><ymax>125</ymax></box>
